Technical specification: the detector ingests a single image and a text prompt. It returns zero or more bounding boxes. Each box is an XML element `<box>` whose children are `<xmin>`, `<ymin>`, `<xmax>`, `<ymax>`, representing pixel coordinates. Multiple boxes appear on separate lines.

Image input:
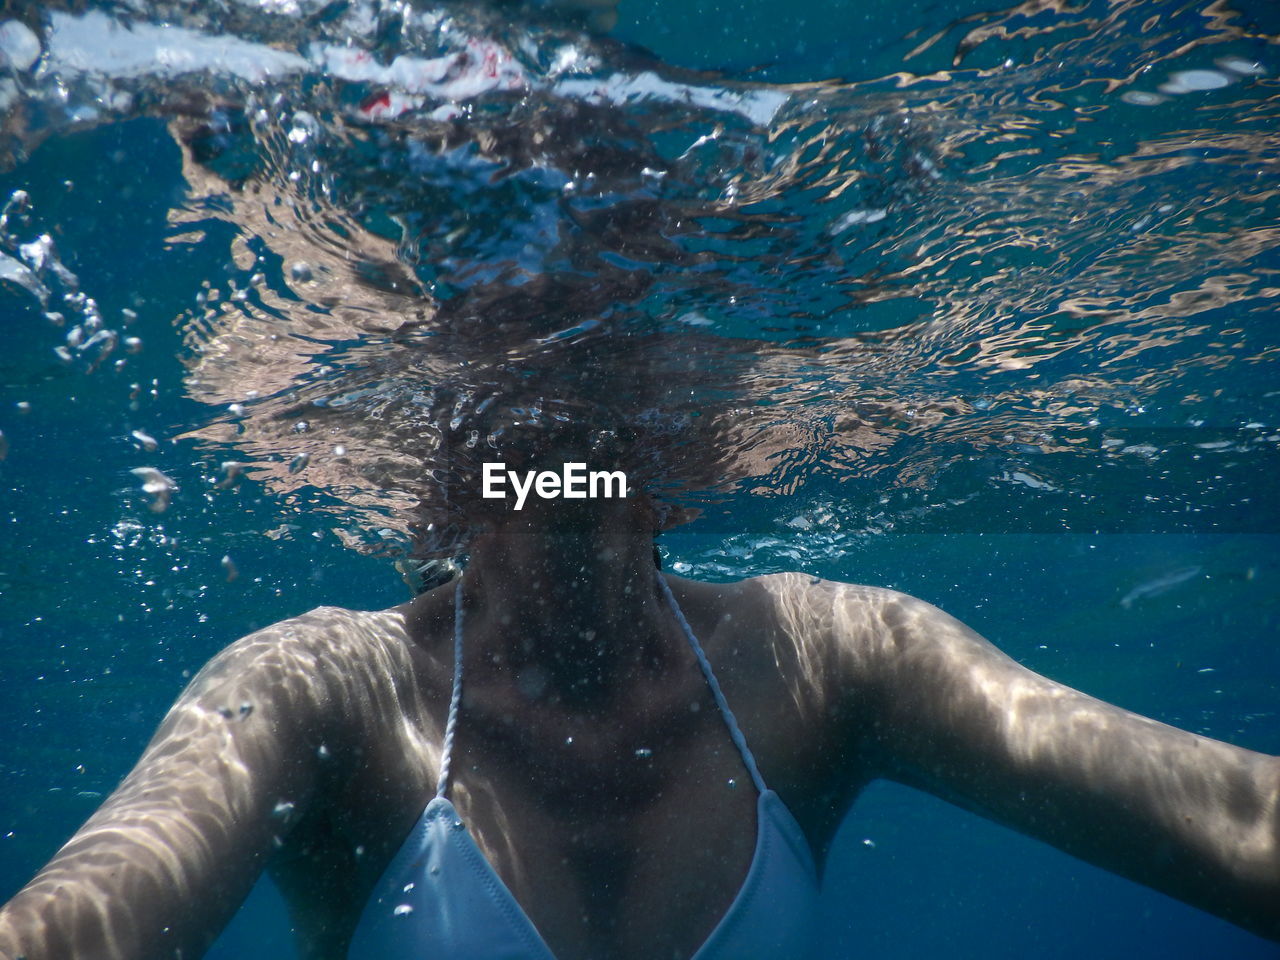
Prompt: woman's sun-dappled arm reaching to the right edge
<box><xmin>835</xmin><ymin>588</ymin><xmax>1280</xmax><ymax>940</ymax></box>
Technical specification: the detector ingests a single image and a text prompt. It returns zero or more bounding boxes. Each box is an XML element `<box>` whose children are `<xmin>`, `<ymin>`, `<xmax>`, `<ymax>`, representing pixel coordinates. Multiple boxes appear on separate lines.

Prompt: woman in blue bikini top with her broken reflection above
<box><xmin>0</xmin><ymin>0</ymin><xmax>1280</xmax><ymax>960</ymax></box>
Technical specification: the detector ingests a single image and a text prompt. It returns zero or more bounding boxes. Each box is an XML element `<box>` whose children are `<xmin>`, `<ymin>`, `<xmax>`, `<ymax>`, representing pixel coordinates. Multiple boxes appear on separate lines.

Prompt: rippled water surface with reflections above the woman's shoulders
<box><xmin>0</xmin><ymin>3</ymin><xmax>1280</xmax><ymax>556</ymax></box>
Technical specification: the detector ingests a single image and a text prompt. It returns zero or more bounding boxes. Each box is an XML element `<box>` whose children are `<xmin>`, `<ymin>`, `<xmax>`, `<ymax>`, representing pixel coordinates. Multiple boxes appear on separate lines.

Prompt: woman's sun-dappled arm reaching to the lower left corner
<box><xmin>0</xmin><ymin>622</ymin><xmax>328</xmax><ymax>960</ymax></box>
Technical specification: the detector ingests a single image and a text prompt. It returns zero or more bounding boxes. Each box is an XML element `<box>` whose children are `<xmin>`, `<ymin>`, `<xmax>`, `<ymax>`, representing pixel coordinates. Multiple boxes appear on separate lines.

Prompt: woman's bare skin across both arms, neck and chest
<box><xmin>0</xmin><ymin>499</ymin><xmax>1280</xmax><ymax>960</ymax></box>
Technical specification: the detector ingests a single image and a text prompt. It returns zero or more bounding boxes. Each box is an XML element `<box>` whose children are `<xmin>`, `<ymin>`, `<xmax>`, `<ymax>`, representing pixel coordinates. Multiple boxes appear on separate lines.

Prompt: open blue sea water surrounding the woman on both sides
<box><xmin>0</xmin><ymin>0</ymin><xmax>1280</xmax><ymax>960</ymax></box>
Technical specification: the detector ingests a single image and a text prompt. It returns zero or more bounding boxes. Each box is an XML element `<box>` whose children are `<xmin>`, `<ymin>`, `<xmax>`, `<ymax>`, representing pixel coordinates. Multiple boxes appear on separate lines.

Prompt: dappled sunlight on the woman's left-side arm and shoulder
<box><xmin>0</xmin><ymin>608</ymin><xmax>450</xmax><ymax>960</ymax></box>
